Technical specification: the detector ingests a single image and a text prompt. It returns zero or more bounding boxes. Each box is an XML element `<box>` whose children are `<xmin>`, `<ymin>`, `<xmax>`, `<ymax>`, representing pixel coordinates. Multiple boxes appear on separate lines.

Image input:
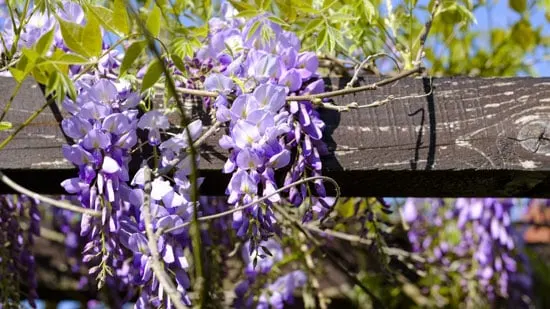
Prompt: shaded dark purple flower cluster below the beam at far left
<box><xmin>0</xmin><ymin>195</ymin><xmax>40</xmax><ymax>308</ymax></box>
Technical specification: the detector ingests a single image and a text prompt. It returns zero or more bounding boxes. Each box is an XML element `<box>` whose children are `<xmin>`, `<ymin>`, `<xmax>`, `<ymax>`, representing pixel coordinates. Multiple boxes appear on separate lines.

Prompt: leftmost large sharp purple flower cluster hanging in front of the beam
<box><xmin>61</xmin><ymin>74</ymin><xmax>140</xmax><ymax>285</ymax></box>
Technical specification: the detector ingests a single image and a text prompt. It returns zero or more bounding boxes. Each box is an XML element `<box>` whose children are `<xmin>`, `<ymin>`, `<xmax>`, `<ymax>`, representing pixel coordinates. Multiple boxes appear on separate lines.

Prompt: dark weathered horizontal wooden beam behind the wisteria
<box><xmin>0</xmin><ymin>78</ymin><xmax>550</xmax><ymax>197</ymax></box>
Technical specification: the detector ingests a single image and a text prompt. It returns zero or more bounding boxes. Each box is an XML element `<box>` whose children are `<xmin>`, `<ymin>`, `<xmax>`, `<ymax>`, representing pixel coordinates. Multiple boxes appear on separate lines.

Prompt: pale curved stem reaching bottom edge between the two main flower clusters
<box><xmin>142</xmin><ymin>166</ymin><xmax>189</xmax><ymax>309</ymax></box>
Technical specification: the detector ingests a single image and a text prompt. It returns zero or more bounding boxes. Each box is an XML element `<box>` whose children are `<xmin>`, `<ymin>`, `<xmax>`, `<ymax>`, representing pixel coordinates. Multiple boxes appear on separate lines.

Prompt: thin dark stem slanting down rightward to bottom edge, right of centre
<box><xmin>273</xmin><ymin>204</ymin><xmax>386</xmax><ymax>308</ymax></box>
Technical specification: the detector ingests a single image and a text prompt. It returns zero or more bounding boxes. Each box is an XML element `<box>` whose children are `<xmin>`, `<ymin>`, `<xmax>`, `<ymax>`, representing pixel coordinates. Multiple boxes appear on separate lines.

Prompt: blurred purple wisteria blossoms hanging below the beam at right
<box><xmin>402</xmin><ymin>198</ymin><xmax>531</xmax><ymax>304</ymax></box>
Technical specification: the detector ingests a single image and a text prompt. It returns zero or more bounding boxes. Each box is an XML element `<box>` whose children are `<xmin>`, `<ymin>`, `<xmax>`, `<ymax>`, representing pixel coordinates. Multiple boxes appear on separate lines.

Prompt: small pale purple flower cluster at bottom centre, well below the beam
<box><xmin>234</xmin><ymin>238</ymin><xmax>307</xmax><ymax>309</ymax></box>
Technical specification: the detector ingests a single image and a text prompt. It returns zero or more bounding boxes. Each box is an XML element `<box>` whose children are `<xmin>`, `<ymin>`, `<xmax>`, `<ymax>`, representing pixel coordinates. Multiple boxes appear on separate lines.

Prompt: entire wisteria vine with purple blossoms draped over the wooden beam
<box><xmin>0</xmin><ymin>0</ymin><xmax>544</xmax><ymax>309</ymax></box>
